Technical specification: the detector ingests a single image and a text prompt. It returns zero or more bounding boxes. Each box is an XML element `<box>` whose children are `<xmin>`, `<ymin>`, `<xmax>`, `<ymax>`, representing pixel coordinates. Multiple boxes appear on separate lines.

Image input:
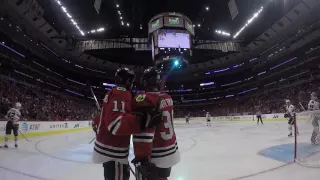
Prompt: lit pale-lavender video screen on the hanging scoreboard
<box><xmin>158</xmin><ymin>31</ymin><xmax>190</xmax><ymax>49</ymax></box>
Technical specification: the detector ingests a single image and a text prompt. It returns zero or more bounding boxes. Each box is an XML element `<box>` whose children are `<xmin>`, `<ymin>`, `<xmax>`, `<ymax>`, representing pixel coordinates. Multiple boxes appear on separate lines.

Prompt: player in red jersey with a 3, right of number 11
<box><xmin>132</xmin><ymin>68</ymin><xmax>180</xmax><ymax>180</ymax></box>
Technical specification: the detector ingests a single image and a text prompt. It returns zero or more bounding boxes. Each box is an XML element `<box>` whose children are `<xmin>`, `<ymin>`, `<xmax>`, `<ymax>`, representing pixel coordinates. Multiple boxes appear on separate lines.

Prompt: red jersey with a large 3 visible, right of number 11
<box><xmin>132</xmin><ymin>92</ymin><xmax>180</xmax><ymax>168</ymax></box>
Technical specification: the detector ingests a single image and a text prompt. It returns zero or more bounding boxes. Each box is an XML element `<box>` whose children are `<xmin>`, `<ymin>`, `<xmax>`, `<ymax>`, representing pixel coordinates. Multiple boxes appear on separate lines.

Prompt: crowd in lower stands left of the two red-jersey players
<box><xmin>0</xmin><ymin>78</ymin><xmax>94</xmax><ymax>121</ymax></box>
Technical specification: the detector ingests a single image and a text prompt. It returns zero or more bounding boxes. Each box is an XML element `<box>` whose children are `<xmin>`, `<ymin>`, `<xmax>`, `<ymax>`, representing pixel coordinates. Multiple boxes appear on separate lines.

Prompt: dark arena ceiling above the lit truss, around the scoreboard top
<box><xmin>38</xmin><ymin>0</ymin><xmax>301</xmax><ymax>40</ymax></box>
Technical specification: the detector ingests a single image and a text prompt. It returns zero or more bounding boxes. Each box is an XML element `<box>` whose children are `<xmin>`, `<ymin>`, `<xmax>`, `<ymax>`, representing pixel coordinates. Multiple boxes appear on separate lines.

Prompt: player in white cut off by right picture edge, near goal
<box><xmin>308</xmin><ymin>92</ymin><xmax>320</xmax><ymax>145</ymax></box>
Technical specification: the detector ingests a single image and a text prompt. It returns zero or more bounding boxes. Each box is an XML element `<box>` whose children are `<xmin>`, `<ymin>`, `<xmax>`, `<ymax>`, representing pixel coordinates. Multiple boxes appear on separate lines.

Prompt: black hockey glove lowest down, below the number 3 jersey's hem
<box><xmin>131</xmin><ymin>158</ymin><xmax>158</xmax><ymax>180</ymax></box>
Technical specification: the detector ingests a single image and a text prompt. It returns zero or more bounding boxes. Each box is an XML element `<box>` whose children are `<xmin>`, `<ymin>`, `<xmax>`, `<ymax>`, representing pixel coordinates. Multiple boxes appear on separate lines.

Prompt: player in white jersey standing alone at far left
<box><xmin>4</xmin><ymin>102</ymin><xmax>21</xmax><ymax>148</ymax></box>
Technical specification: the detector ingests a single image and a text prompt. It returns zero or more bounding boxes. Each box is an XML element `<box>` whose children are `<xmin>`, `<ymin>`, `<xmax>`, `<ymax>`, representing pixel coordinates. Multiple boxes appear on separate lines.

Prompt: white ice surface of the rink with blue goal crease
<box><xmin>0</xmin><ymin>120</ymin><xmax>320</xmax><ymax>180</ymax></box>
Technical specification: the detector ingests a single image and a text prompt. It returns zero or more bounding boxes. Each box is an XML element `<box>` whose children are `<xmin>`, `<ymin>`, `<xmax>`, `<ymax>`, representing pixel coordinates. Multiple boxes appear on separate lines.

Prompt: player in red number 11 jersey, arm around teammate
<box><xmin>92</xmin><ymin>68</ymin><xmax>161</xmax><ymax>180</ymax></box>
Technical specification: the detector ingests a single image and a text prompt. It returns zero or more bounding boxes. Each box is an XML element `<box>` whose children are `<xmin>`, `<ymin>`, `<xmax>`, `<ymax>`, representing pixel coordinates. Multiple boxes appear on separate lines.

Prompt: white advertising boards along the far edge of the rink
<box><xmin>0</xmin><ymin>112</ymin><xmax>308</xmax><ymax>138</ymax></box>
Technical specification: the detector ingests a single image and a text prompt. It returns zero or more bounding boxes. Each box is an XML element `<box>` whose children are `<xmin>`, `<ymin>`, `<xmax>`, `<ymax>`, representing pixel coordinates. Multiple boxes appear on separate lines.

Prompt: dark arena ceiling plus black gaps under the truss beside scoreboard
<box><xmin>38</xmin><ymin>0</ymin><xmax>301</xmax><ymax>66</ymax></box>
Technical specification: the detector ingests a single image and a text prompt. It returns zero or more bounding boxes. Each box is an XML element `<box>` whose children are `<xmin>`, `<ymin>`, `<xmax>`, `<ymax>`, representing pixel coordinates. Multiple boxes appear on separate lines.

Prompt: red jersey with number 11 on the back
<box><xmin>92</xmin><ymin>87</ymin><xmax>140</xmax><ymax>164</ymax></box>
